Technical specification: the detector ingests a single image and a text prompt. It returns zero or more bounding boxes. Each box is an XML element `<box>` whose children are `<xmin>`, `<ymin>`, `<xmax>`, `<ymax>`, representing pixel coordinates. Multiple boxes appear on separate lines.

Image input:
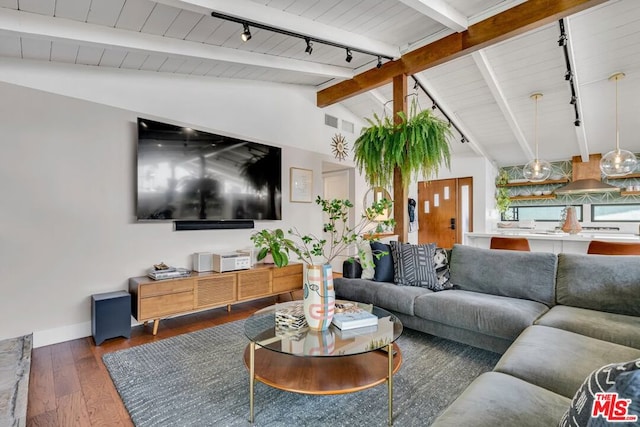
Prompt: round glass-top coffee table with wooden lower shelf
<box><xmin>244</xmin><ymin>301</ymin><xmax>402</xmax><ymax>425</ymax></box>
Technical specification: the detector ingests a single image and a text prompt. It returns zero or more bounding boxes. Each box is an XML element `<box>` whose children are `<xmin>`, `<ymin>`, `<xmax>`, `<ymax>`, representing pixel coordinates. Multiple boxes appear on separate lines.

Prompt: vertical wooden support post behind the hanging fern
<box><xmin>393</xmin><ymin>74</ymin><xmax>409</xmax><ymax>243</ymax></box>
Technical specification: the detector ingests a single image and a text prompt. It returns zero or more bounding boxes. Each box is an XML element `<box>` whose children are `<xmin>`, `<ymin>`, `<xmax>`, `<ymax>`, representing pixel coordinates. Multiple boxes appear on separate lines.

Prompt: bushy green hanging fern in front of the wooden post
<box><xmin>353</xmin><ymin>99</ymin><xmax>452</xmax><ymax>188</ymax></box>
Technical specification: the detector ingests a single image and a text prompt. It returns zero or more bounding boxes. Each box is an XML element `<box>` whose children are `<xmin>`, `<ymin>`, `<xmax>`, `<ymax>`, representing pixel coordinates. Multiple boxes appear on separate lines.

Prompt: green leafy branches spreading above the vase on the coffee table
<box><xmin>251</xmin><ymin>196</ymin><xmax>395</xmax><ymax>267</ymax></box>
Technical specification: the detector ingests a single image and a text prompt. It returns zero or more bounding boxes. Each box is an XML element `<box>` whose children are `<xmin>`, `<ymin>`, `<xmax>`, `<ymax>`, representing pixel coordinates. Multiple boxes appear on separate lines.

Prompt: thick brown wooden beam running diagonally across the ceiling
<box><xmin>316</xmin><ymin>0</ymin><xmax>608</xmax><ymax>107</ymax></box>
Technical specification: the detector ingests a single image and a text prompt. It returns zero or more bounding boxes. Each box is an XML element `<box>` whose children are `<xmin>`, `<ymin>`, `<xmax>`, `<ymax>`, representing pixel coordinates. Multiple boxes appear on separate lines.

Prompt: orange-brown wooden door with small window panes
<box><xmin>416</xmin><ymin>178</ymin><xmax>473</xmax><ymax>249</ymax></box>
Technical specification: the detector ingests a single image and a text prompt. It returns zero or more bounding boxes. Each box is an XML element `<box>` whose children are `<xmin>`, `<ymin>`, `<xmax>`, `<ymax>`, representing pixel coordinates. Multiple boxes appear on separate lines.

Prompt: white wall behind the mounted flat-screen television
<box><xmin>0</xmin><ymin>60</ymin><xmax>360</xmax><ymax>346</ymax></box>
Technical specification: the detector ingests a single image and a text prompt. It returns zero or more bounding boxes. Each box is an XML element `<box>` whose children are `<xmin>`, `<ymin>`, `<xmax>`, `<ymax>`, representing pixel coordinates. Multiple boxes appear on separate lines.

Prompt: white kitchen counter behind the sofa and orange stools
<box><xmin>465</xmin><ymin>229</ymin><xmax>640</xmax><ymax>254</ymax></box>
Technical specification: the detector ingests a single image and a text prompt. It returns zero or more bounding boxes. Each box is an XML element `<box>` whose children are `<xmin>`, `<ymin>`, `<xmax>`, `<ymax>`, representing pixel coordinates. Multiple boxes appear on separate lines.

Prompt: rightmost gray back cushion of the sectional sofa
<box><xmin>556</xmin><ymin>253</ymin><xmax>640</xmax><ymax>316</ymax></box>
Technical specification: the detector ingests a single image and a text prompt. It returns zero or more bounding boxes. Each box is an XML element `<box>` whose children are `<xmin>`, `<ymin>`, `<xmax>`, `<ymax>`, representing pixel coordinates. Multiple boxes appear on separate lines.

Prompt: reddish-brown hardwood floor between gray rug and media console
<box><xmin>27</xmin><ymin>297</ymin><xmax>276</xmax><ymax>427</ymax></box>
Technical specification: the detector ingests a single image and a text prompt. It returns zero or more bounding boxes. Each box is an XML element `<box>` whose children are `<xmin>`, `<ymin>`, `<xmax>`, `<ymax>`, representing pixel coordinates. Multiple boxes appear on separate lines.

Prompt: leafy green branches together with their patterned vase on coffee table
<box><xmin>251</xmin><ymin>196</ymin><xmax>395</xmax><ymax>331</ymax></box>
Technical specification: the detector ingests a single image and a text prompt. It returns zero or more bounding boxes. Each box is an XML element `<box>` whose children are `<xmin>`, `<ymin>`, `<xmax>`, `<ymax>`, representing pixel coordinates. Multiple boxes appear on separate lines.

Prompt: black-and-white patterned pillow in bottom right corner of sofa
<box><xmin>558</xmin><ymin>359</ymin><xmax>640</xmax><ymax>427</ymax></box>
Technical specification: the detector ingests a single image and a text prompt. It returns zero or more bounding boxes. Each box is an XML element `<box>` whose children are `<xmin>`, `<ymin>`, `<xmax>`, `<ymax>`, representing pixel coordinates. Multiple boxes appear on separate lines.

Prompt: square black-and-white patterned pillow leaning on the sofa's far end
<box><xmin>390</xmin><ymin>242</ymin><xmax>438</xmax><ymax>289</ymax></box>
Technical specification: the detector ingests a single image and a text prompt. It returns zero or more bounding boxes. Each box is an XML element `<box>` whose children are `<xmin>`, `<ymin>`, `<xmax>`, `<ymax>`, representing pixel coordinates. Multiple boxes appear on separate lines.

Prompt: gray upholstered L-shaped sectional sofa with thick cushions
<box><xmin>334</xmin><ymin>245</ymin><xmax>640</xmax><ymax>427</ymax></box>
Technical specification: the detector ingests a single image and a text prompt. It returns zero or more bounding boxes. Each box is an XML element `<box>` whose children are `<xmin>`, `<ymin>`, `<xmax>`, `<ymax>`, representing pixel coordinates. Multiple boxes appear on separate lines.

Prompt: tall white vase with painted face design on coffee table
<box><xmin>303</xmin><ymin>264</ymin><xmax>336</xmax><ymax>331</ymax></box>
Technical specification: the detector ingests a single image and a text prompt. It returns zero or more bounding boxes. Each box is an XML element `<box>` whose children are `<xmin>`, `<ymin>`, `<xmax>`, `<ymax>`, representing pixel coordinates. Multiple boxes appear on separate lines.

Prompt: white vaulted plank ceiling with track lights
<box><xmin>0</xmin><ymin>0</ymin><xmax>640</xmax><ymax>170</ymax></box>
